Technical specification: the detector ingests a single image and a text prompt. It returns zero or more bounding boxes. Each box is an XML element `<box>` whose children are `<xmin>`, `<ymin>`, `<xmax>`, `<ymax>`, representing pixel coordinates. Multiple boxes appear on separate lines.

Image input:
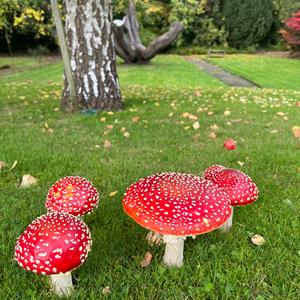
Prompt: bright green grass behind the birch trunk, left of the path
<box><xmin>3</xmin><ymin>55</ymin><xmax>223</xmax><ymax>87</ymax></box>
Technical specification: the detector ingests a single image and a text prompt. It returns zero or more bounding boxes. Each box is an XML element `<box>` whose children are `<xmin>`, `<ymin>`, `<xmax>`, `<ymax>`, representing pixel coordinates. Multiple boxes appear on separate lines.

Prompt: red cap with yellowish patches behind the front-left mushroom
<box><xmin>46</xmin><ymin>176</ymin><xmax>99</xmax><ymax>216</ymax></box>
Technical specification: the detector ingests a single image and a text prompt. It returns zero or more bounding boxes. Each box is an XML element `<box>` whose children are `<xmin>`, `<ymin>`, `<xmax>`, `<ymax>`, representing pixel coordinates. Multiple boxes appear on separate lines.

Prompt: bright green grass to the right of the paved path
<box><xmin>205</xmin><ymin>54</ymin><xmax>300</xmax><ymax>90</ymax></box>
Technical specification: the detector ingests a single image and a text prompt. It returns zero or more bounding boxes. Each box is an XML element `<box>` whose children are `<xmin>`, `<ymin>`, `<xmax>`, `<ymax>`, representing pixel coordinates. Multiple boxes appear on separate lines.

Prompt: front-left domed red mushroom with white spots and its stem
<box><xmin>15</xmin><ymin>212</ymin><xmax>92</xmax><ymax>296</ymax></box>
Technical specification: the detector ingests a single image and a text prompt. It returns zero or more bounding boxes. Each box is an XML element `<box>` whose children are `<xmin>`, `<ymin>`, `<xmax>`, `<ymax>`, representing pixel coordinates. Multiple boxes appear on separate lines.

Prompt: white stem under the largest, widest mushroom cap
<box><xmin>163</xmin><ymin>235</ymin><xmax>185</xmax><ymax>267</ymax></box>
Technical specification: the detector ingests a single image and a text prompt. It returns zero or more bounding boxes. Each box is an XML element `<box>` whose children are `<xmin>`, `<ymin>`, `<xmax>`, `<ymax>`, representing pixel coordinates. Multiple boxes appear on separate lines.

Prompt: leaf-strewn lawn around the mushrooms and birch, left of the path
<box><xmin>0</xmin><ymin>56</ymin><xmax>300</xmax><ymax>300</ymax></box>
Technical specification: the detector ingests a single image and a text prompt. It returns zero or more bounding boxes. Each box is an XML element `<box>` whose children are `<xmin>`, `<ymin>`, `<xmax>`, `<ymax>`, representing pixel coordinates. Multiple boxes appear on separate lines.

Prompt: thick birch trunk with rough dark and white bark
<box><xmin>62</xmin><ymin>0</ymin><xmax>122</xmax><ymax>110</ymax></box>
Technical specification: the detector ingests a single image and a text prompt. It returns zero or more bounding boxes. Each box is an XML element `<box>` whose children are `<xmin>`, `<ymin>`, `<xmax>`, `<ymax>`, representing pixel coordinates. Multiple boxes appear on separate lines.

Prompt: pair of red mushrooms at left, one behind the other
<box><xmin>15</xmin><ymin>176</ymin><xmax>99</xmax><ymax>297</ymax></box>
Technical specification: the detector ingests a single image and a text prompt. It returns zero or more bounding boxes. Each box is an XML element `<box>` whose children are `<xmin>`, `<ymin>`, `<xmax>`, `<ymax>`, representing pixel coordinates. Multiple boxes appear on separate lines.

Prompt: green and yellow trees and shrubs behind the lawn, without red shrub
<box><xmin>0</xmin><ymin>0</ymin><xmax>300</xmax><ymax>52</ymax></box>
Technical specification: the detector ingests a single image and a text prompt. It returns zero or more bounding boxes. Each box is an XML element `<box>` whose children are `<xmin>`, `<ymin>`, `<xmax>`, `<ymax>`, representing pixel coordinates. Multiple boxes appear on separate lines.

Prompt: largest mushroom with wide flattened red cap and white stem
<box><xmin>123</xmin><ymin>173</ymin><xmax>231</xmax><ymax>267</ymax></box>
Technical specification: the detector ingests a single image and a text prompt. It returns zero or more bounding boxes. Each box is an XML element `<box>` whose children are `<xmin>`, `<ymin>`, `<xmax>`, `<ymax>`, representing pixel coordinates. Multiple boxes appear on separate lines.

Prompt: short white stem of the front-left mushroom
<box><xmin>49</xmin><ymin>272</ymin><xmax>74</xmax><ymax>297</ymax></box>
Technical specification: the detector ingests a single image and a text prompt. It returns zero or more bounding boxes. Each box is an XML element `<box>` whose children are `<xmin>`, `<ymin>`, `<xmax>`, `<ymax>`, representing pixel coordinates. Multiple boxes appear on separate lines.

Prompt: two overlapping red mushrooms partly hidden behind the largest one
<box><xmin>203</xmin><ymin>165</ymin><xmax>259</xmax><ymax>232</ymax></box>
